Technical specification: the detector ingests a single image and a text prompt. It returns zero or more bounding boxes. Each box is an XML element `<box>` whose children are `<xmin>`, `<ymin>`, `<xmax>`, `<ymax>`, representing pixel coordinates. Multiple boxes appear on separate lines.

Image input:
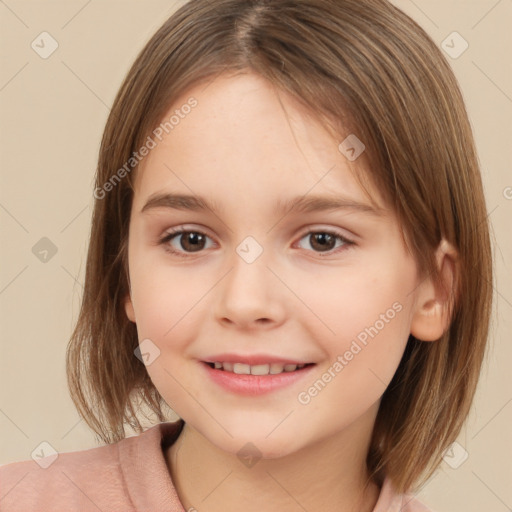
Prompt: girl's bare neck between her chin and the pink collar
<box><xmin>166</xmin><ymin>404</ymin><xmax>380</xmax><ymax>512</ymax></box>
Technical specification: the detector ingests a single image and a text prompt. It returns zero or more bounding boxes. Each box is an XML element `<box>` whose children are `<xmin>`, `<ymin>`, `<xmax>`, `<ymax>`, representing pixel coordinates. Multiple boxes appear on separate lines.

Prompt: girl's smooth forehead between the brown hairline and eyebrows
<box><xmin>135</xmin><ymin>74</ymin><xmax>382</xmax><ymax>212</ymax></box>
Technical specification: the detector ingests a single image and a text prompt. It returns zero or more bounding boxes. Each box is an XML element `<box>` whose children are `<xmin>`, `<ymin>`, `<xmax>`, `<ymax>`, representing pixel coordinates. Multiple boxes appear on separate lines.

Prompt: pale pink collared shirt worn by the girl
<box><xmin>0</xmin><ymin>421</ymin><xmax>431</xmax><ymax>512</ymax></box>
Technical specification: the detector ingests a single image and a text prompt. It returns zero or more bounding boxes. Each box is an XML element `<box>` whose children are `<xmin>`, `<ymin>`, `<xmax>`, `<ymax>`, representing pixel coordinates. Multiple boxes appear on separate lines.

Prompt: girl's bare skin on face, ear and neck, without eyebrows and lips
<box><xmin>125</xmin><ymin>74</ymin><xmax>451</xmax><ymax>512</ymax></box>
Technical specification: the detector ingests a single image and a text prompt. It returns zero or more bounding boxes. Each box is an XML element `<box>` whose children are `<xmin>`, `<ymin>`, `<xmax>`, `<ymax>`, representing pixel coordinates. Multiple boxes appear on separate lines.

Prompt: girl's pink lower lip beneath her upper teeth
<box><xmin>201</xmin><ymin>362</ymin><xmax>315</xmax><ymax>396</ymax></box>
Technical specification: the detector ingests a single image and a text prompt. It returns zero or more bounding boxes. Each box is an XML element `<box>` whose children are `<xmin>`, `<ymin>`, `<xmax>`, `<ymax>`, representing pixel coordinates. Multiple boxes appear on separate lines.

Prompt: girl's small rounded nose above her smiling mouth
<box><xmin>215</xmin><ymin>246</ymin><xmax>290</xmax><ymax>329</ymax></box>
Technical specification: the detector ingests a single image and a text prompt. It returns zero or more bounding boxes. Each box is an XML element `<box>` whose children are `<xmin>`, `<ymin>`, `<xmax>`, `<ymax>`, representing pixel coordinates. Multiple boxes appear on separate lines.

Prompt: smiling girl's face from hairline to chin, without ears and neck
<box><xmin>126</xmin><ymin>70</ymin><xmax>419</xmax><ymax>458</ymax></box>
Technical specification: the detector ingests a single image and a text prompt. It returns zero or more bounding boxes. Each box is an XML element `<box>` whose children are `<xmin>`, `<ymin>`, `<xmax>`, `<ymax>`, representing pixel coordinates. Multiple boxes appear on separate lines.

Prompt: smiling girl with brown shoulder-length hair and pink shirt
<box><xmin>0</xmin><ymin>0</ymin><xmax>492</xmax><ymax>512</ymax></box>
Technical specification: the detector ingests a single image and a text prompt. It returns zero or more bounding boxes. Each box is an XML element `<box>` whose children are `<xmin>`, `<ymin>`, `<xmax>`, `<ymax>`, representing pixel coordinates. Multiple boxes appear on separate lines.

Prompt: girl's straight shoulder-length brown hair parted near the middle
<box><xmin>67</xmin><ymin>0</ymin><xmax>492</xmax><ymax>492</ymax></box>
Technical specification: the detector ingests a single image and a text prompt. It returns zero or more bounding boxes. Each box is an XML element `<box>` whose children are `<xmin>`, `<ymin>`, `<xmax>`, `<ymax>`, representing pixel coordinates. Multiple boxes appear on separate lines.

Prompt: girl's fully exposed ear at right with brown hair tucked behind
<box><xmin>411</xmin><ymin>239</ymin><xmax>458</xmax><ymax>341</ymax></box>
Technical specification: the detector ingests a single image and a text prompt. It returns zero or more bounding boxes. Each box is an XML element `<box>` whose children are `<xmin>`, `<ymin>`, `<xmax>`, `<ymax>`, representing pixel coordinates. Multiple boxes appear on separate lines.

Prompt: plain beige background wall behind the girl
<box><xmin>0</xmin><ymin>0</ymin><xmax>512</xmax><ymax>512</ymax></box>
